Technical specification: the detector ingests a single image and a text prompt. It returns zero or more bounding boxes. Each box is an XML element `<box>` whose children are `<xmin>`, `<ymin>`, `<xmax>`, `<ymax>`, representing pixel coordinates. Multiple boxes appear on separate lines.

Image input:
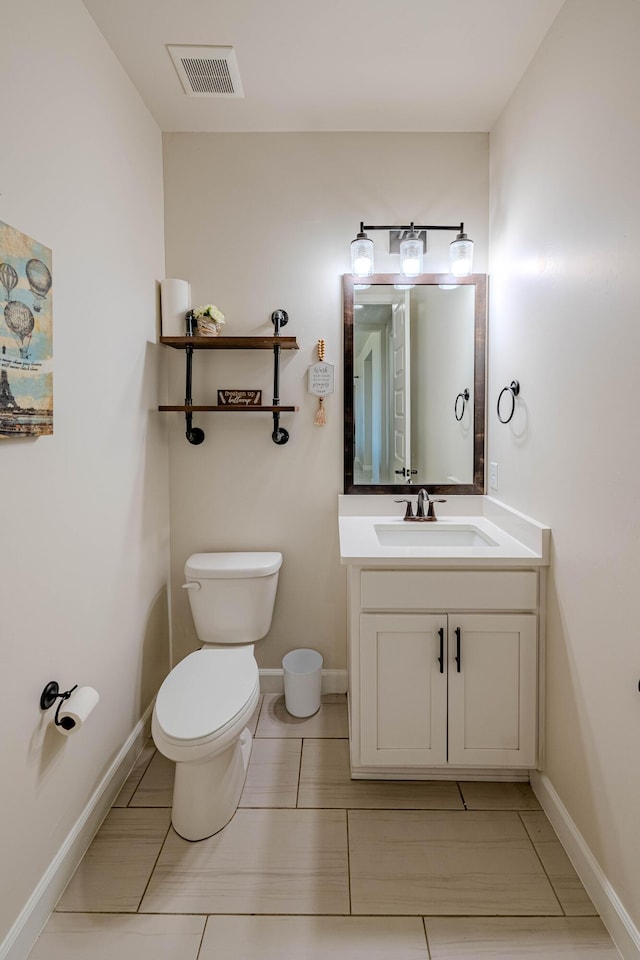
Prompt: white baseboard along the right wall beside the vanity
<box><xmin>531</xmin><ymin>770</ymin><xmax>640</xmax><ymax>960</ymax></box>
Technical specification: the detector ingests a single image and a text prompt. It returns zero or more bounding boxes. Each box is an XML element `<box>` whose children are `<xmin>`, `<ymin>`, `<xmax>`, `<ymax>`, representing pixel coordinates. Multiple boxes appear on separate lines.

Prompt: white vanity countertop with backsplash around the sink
<box><xmin>338</xmin><ymin>495</ymin><xmax>550</xmax><ymax>567</ymax></box>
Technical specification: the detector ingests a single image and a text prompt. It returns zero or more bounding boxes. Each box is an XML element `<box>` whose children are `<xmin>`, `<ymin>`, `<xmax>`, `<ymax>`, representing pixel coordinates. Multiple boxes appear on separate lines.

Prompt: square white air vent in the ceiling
<box><xmin>167</xmin><ymin>44</ymin><xmax>244</xmax><ymax>97</ymax></box>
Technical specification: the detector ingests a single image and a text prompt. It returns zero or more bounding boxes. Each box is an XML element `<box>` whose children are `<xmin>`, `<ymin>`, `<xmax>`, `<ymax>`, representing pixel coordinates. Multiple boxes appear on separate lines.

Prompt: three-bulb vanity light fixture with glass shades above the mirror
<box><xmin>351</xmin><ymin>221</ymin><xmax>473</xmax><ymax>277</ymax></box>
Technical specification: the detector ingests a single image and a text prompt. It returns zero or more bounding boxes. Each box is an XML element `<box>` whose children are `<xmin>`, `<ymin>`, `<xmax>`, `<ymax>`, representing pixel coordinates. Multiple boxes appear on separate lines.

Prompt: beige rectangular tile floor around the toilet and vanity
<box><xmin>30</xmin><ymin>695</ymin><xmax>619</xmax><ymax>960</ymax></box>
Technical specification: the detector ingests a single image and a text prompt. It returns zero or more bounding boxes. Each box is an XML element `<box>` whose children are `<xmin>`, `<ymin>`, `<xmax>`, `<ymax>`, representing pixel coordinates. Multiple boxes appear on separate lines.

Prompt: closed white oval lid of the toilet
<box><xmin>155</xmin><ymin>644</ymin><xmax>259</xmax><ymax>741</ymax></box>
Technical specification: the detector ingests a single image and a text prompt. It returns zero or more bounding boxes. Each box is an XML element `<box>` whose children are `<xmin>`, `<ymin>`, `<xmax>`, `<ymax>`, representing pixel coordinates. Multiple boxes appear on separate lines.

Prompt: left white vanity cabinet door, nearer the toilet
<box><xmin>360</xmin><ymin>613</ymin><xmax>447</xmax><ymax>767</ymax></box>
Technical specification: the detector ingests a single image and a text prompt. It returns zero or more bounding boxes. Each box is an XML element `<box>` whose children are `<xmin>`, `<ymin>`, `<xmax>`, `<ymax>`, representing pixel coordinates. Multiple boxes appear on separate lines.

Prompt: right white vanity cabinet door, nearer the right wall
<box><xmin>448</xmin><ymin>614</ymin><xmax>537</xmax><ymax>767</ymax></box>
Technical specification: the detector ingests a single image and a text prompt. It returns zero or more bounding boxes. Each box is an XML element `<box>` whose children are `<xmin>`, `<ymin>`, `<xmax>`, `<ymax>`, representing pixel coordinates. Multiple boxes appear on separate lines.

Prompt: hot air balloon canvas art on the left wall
<box><xmin>0</xmin><ymin>220</ymin><xmax>53</xmax><ymax>439</ymax></box>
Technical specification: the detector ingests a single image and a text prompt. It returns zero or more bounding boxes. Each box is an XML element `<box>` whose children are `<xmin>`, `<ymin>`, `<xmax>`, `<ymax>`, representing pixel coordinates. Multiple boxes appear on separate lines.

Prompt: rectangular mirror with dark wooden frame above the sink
<box><xmin>344</xmin><ymin>274</ymin><xmax>487</xmax><ymax>494</ymax></box>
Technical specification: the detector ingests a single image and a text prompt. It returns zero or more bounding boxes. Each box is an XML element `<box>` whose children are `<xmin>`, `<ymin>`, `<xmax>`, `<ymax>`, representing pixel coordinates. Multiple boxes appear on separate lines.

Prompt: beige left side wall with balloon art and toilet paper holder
<box><xmin>0</xmin><ymin>0</ymin><xmax>168</xmax><ymax>949</ymax></box>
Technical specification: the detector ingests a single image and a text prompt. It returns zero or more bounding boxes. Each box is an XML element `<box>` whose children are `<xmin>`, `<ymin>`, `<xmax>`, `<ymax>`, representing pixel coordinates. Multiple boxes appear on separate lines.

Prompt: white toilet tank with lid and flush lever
<box><xmin>184</xmin><ymin>552</ymin><xmax>282</xmax><ymax>643</ymax></box>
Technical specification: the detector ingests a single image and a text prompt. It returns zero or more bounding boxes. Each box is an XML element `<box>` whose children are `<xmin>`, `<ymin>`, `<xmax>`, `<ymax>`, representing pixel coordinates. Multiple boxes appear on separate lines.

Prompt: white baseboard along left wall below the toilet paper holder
<box><xmin>0</xmin><ymin>703</ymin><xmax>153</xmax><ymax>960</ymax></box>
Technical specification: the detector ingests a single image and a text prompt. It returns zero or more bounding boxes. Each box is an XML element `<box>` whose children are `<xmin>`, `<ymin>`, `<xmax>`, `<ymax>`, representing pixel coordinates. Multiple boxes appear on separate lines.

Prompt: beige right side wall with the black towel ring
<box><xmin>489</xmin><ymin>0</ymin><xmax>640</xmax><ymax>926</ymax></box>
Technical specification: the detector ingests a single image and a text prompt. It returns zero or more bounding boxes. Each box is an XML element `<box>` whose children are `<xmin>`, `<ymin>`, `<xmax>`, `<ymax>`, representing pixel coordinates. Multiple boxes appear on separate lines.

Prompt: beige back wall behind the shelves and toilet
<box><xmin>164</xmin><ymin>134</ymin><xmax>488</xmax><ymax>669</ymax></box>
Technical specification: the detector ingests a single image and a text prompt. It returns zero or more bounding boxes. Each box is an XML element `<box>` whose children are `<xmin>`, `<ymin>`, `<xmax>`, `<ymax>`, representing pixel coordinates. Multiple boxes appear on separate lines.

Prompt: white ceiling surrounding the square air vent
<box><xmin>84</xmin><ymin>0</ymin><xmax>564</xmax><ymax>132</ymax></box>
